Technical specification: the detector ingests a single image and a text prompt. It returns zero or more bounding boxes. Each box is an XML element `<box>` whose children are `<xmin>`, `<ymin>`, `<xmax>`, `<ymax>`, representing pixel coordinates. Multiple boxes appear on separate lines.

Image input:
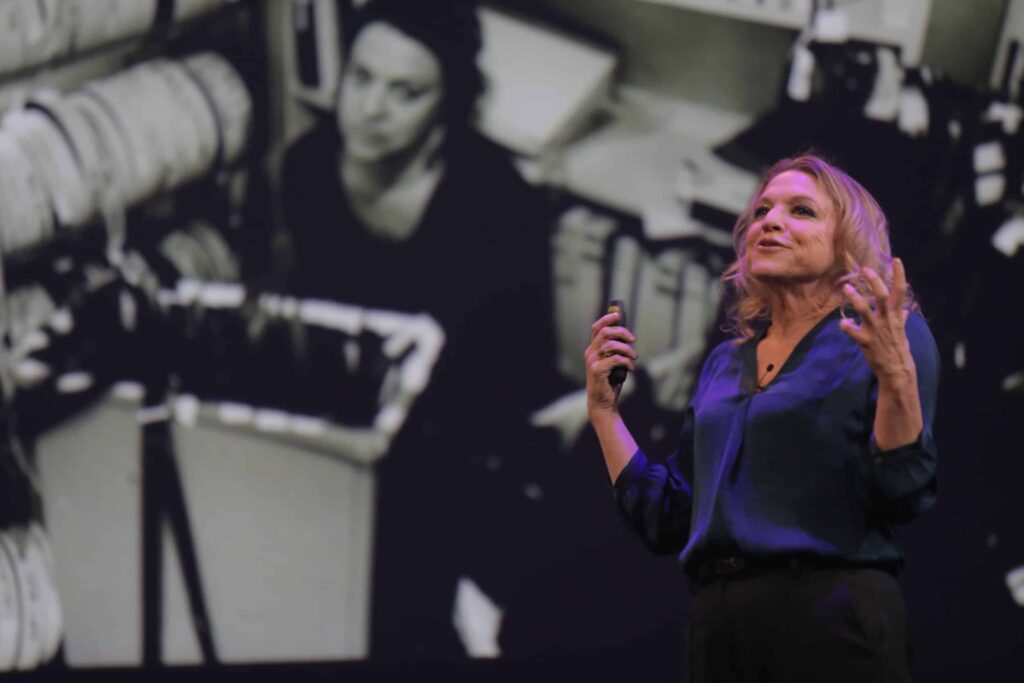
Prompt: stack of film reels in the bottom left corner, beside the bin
<box><xmin>0</xmin><ymin>440</ymin><xmax>63</xmax><ymax>672</ymax></box>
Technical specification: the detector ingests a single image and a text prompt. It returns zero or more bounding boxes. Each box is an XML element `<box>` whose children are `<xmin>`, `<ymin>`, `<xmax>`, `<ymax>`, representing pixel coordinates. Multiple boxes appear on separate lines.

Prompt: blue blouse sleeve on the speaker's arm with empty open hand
<box><xmin>868</xmin><ymin>313</ymin><xmax>939</xmax><ymax>523</ymax></box>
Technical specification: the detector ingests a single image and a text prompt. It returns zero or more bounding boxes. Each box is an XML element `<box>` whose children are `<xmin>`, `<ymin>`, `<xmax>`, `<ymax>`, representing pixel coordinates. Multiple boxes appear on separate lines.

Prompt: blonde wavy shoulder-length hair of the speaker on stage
<box><xmin>722</xmin><ymin>154</ymin><xmax>919</xmax><ymax>339</ymax></box>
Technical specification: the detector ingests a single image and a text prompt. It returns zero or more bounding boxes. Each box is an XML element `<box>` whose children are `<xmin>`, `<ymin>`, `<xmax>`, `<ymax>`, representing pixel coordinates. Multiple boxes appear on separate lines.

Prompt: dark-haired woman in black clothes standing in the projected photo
<box><xmin>282</xmin><ymin>0</ymin><xmax>555</xmax><ymax>660</ymax></box>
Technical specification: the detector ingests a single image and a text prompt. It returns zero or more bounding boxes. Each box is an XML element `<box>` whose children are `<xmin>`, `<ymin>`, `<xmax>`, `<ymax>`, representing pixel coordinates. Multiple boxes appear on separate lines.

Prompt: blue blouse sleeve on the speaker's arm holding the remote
<box><xmin>612</xmin><ymin>407</ymin><xmax>693</xmax><ymax>555</ymax></box>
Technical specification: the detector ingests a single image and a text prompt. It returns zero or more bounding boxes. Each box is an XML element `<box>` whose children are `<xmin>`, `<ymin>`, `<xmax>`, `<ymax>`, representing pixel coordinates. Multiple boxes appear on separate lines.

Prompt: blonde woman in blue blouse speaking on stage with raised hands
<box><xmin>585</xmin><ymin>155</ymin><xmax>939</xmax><ymax>683</ymax></box>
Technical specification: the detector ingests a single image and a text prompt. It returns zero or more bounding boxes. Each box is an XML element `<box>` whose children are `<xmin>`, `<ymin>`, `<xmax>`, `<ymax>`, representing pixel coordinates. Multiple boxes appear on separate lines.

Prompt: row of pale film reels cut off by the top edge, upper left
<box><xmin>0</xmin><ymin>0</ymin><xmax>230</xmax><ymax>74</ymax></box>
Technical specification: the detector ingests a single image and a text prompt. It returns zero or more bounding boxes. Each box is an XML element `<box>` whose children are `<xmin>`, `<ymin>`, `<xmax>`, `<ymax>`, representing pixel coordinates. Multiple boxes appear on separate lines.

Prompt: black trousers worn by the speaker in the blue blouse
<box><xmin>687</xmin><ymin>568</ymin><xmax>910</xmax><ymax>683</ymax></box>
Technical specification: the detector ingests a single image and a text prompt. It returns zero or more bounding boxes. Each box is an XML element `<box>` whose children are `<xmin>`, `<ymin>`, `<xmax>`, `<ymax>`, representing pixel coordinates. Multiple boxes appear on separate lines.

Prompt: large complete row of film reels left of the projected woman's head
<box><xmin>0</xmin><ymin>52</ymin><xmax>253</xmax><ymax>254</ymax></box>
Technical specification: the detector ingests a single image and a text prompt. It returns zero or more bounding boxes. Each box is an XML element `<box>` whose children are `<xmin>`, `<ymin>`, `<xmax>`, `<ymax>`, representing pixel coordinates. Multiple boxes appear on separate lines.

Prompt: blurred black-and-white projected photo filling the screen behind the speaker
<box><xmin>0</xmin><ymin>0</ymin><xmax>1024</xmax><ymax>681</ymax></box>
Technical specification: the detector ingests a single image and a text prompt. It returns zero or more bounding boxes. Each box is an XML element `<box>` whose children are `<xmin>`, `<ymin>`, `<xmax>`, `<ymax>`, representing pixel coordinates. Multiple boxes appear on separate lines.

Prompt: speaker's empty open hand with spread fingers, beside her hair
<box><xmin>840</xmin><ymin>258</ymin><xmax>915</xmax><ymax>383</ymax></box>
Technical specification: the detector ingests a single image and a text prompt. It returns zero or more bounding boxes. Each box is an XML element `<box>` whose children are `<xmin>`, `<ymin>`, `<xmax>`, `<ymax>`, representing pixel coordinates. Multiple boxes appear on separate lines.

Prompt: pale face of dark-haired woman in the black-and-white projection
<box><xmin>338</xmin><ymin>22</ymin><xmax>444</xmax><ymax>162</ymax></box>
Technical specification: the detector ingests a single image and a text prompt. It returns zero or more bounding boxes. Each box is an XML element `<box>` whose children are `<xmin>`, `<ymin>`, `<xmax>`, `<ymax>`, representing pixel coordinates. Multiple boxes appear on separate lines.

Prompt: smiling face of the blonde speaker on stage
<box><xmin>746</xmin><ymin>171</ymin><xmax>836</xmax><ymax>283</ymax></box>
